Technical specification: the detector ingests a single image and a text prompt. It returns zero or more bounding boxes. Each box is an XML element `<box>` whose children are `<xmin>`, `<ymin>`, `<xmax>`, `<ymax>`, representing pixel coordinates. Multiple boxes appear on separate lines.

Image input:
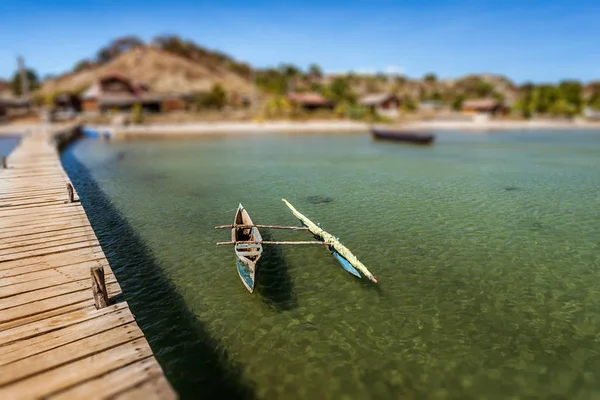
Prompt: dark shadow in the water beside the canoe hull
<box><xmin>256</xmin><ymin>231</ymin><xmax>298</xmax><ymax>312</ymax></box>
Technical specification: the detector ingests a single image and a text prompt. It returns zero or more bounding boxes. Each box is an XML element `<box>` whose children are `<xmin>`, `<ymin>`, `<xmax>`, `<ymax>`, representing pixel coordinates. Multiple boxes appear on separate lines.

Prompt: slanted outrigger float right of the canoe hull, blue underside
<box><xmin>281</xmin><ymin>199</ymin><xmax>377</xmax><ymax>283</ymax></box>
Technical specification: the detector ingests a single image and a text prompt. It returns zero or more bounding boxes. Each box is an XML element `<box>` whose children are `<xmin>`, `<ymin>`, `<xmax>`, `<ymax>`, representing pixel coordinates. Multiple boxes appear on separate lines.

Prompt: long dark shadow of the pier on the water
<box><xmin>61</xmin><ymin>147</ymin><xmax>256</xmax><ymax>399</ymax></box>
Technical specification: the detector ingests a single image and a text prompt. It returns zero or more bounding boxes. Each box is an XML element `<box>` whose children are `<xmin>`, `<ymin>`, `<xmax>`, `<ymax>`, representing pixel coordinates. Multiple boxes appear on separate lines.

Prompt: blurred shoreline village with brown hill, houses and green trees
<box><xmin>0</xmin><ymin>36</ymin><xmax>600</xmax><ymax>123</ymax></box>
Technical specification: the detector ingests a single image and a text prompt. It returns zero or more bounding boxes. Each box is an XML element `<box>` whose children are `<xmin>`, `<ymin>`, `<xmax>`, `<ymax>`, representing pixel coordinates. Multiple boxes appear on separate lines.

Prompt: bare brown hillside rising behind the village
<box><xmin>39</xmin><ymin>45</ymin><xmax>252</xmax><ymax>95</ymax></box>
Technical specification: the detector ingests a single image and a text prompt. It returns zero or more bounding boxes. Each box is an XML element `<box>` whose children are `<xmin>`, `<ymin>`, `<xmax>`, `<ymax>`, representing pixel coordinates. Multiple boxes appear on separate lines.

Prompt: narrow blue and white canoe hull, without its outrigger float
<box><xmin>231</xmin><ymin>204</ymin><xmax>262</xmax><ymax>293</ymax></box>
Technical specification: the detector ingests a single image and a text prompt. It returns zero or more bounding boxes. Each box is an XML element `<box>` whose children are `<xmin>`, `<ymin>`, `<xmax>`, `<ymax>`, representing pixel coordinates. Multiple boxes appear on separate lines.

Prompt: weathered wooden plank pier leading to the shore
<box><xmin>0</xmin><ymin>130</ymin><xmax>177</xmax><ymax>399</ymax></box>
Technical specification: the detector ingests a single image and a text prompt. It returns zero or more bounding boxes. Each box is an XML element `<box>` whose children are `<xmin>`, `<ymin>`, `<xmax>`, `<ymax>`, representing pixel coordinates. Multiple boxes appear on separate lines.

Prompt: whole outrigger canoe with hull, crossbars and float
<box><xmin>215</xmin><ymin>199</ymin><xmax>377</xmax><ymax>293</ymax></box>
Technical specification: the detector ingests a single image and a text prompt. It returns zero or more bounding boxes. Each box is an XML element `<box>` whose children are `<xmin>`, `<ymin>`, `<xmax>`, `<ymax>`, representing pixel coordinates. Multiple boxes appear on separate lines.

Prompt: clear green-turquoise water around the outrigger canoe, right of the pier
<box><xmin>63</xmin><ymin>132</ymin><xmax>600</xmax><ymax>399</ymax></box>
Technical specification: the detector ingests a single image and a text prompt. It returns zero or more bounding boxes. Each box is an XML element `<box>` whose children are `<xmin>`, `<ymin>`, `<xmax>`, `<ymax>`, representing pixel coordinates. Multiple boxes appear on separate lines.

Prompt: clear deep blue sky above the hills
<box><xmin>0</xmin><ymin>0</ymin><xmax>600</xmax><ymax>83</ymax></box>
